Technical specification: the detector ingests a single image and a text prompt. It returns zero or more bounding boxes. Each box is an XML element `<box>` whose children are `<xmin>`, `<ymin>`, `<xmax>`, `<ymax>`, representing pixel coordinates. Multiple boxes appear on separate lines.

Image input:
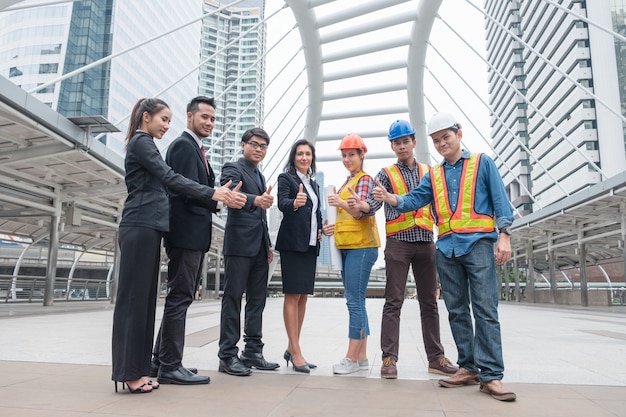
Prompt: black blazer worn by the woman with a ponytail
<box><xmin>120</xmin><ymin>132</ymin><xmax>214</xmax><ymax>232</ymax></box>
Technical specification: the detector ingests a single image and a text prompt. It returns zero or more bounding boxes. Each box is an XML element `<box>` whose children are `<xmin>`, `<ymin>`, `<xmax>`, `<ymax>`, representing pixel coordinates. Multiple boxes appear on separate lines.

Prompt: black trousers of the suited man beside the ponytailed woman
<box><xmin>152</xmin><ymin>248</ymin><xmax>204</xmax><ymax>371</ymax></box>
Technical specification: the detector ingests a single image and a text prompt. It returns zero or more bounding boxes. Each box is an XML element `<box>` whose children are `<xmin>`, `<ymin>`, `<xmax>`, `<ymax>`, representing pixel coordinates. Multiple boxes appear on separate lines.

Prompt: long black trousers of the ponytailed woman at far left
<box><xmin>111</xmin><ymin>227</ymin><xmax>162</xmax><ymax>381</ymax></box>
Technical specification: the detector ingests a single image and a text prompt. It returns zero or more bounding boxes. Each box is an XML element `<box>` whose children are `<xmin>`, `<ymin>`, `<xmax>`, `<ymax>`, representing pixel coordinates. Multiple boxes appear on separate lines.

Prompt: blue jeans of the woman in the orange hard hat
<box><xmin>341</xmin><ymin>248</ymin><xmax>378</xmax><ymax>340</ymax></box>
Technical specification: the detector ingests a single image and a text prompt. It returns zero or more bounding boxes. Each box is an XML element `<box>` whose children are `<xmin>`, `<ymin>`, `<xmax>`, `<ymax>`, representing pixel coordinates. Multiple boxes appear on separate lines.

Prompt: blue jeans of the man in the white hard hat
<box><xmin>436</xmin><ymin>239</ymin><xmax>504</xmax><ymax>382</ymax></box>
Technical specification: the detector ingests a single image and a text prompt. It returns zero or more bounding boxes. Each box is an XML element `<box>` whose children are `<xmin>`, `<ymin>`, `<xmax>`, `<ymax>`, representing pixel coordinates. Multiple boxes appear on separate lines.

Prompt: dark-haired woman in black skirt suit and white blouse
<box><xmin>276</xmin><ymin>139</ymin><xmax>322</xmax><ymax>373</ymax></box>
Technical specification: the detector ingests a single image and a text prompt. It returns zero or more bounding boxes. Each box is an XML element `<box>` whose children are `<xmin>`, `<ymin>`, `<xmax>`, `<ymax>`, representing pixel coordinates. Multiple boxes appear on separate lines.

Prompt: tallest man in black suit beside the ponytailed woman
<box><xmin>151</xmin><ymin>96</ymin><xmax>245</xmax><ymax>385</ymax></box>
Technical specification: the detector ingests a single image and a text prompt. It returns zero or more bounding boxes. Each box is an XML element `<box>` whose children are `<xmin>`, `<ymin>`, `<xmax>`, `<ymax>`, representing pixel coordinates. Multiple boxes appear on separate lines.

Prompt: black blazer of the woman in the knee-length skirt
<box><xmin>276</xmin><ymin>173</ymin><xmax>322</xmax><ymax>255</ymax></box>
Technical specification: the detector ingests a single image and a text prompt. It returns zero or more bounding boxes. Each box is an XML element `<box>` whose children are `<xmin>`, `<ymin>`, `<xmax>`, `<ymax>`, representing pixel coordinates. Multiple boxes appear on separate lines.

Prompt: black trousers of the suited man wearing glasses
<box><xmin>218</xmin><ymin>245</ymin><xmax>269</xmax><ymax>359</ymax></box>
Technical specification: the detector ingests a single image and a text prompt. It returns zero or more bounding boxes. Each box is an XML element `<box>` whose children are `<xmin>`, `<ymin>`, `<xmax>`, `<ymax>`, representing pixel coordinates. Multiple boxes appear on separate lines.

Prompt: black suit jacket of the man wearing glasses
<box><xmin>220</xmin><ymin>158</ymin><xmax>271</xmax><ymax>256</ymax></box>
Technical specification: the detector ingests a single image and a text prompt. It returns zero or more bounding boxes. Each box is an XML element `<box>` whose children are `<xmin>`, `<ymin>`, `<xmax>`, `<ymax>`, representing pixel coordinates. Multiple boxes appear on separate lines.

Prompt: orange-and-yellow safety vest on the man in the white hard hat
<box><xmin>430</xmin><ymin>153</ymin><xmax>495</xmax><ymax>237</ymax></box>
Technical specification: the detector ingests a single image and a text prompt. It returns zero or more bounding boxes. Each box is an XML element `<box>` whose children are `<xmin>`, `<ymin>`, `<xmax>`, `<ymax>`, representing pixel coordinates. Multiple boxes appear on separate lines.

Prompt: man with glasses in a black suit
<box><xmin>218</xmin><ymin>128</ymin><xmax>280</xmax><ymax>376</ymax></box>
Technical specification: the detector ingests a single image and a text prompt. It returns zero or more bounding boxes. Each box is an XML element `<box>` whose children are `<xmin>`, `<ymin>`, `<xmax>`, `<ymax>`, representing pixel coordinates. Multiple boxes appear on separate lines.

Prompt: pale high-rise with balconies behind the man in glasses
<box><xmin>199</xmin><ymin>0</ymin><xmax>265</xmax><ymax>175</ymax></box>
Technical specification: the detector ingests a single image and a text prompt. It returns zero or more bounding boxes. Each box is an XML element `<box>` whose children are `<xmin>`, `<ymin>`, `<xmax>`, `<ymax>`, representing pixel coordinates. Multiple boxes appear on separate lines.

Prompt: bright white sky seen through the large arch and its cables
<box><xmin>263</xmin><ymin>0</ymin><xmax>490</xmax><ymax>267</ymax></box>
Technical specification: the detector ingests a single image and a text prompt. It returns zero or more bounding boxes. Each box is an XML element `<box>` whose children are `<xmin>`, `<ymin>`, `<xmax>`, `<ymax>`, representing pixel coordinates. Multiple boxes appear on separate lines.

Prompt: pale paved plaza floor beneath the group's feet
<box><xmin>0</xmin><ymin>298</ymin><xmax>626</xmax><ymax>417</ymax></box>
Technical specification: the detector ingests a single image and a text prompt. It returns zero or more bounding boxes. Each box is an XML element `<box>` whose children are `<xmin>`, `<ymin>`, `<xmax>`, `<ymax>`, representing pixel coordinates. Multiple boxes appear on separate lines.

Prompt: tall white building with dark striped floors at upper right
<box><xmin>485</xmin><ymin>0</ymin><xmax>626</xmax><ymax>214</ymax></box>
